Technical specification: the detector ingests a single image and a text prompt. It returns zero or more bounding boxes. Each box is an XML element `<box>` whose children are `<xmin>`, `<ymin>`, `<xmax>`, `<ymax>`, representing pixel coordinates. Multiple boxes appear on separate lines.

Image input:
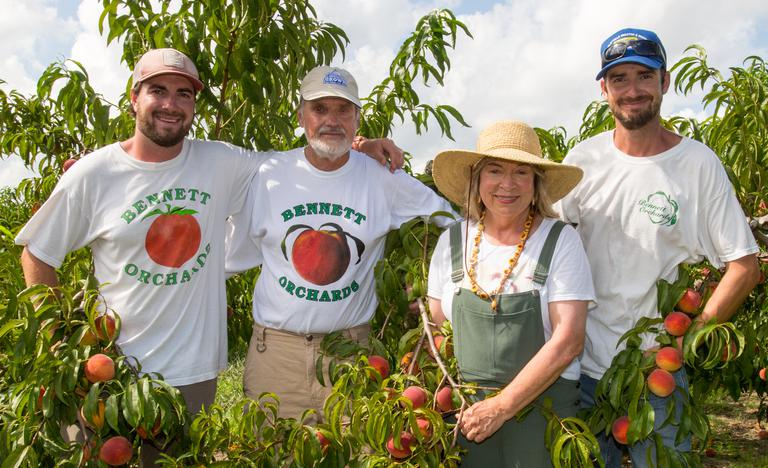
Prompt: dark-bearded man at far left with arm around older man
<box><xmin>16</xmin><ymin>49</ymin><xmax>402</xmax><ymax>452</ymax></box>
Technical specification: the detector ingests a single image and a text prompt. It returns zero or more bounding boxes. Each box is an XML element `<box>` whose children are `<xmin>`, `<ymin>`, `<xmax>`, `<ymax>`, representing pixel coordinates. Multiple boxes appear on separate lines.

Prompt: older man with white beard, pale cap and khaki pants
<box><xmin>226</xmin><ymin>67</ymin><xmax>451</xmax><ymax>422</ymax></box>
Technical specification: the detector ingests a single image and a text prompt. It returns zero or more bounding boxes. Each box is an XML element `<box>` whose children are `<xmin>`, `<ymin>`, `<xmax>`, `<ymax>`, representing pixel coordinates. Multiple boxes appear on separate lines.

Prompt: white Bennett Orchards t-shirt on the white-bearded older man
<box><xmin>226</xmin><ymin>148</ymin><xmax>450</xmax><ymax>333</ymax></box>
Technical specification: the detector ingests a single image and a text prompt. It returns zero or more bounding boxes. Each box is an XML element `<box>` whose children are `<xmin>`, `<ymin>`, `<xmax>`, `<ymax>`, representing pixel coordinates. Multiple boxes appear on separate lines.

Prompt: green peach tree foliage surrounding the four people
<box><xmin>0</xmin><ymin>0</ymin><xmax>768</xmax><ymax>466</ymax></box>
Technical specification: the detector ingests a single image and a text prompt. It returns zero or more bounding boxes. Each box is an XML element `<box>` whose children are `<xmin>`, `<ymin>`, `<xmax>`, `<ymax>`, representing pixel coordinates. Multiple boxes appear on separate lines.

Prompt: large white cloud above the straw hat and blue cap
<box><xmin>352</xmin><ymin>0</ymin><xmax>768</xmax><ymax>169</ymax></box>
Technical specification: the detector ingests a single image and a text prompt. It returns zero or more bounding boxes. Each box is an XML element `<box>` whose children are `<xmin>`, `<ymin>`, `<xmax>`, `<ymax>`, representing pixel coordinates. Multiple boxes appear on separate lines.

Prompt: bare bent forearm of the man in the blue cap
<box><xmin>697</xmin><ymin>254</ymin><xmax>760</xmax><ymax>323</ymax></box>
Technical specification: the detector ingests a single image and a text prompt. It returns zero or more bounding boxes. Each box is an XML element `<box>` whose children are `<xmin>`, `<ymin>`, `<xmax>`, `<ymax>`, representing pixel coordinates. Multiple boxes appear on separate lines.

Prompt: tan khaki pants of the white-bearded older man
<box><xmin>243</xmin><ymin>324</ymin><xmax>371</xmax><ymax>424</ymax></box>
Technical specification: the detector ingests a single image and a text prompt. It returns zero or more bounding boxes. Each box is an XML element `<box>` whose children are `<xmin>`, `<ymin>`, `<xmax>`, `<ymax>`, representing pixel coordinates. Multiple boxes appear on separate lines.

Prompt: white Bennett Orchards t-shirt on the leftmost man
<box><xmin>16</xmin><ymin>140</ymin><xmax>265</xmax><ymax>385</ymax></box>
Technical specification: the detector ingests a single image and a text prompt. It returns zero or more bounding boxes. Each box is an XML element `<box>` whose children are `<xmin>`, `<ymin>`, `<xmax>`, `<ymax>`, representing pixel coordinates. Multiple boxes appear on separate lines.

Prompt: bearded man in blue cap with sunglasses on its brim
<box><xmin>558</xmin><ymin>29</ymin><xmax>759</xmax><ymax>467</ymax></box>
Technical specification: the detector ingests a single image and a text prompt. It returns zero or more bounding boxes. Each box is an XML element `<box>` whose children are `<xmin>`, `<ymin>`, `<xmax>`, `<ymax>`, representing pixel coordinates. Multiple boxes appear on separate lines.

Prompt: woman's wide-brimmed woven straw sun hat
<box><xmin>432</xmin><ymin>120</ymin><xmax>583</xmax><ymax>205</ymax></box>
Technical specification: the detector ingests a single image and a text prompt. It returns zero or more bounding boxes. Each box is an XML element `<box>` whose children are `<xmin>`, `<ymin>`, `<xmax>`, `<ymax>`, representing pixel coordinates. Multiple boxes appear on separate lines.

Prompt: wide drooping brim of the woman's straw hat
<box><xmin>432</xmin><ymin>148</ymin><xmax>584</xmax><ymax>206</ymax></box>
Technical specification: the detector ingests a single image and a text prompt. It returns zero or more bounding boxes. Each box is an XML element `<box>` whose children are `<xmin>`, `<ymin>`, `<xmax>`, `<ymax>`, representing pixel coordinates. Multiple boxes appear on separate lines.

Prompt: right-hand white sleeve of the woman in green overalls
<box><xmin>547</xmin><ymin>225</ymin><xmax>595</xmax><ymax>302</ymax></box>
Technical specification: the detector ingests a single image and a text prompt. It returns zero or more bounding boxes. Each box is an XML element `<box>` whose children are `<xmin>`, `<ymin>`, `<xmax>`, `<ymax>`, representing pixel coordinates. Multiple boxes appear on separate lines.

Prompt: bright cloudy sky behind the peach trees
<box><xmin>0</xmin><ymin>0</ymin><xmax>768</xmax><ymax>187</ymax></box>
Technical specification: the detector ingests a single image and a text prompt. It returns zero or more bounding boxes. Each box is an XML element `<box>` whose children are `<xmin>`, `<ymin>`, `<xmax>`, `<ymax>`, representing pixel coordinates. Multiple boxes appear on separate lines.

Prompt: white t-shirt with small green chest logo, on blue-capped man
<box><xmin>556</xmin><ymin>131</ymin><xmax>758</xmax><ymax>379</ymax></box>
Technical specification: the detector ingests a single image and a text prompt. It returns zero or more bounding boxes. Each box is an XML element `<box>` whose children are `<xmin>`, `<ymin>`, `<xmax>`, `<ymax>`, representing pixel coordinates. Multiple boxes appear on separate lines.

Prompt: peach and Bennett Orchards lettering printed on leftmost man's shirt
<box><xmin>120</xmin><ymin>187</ymin><xmax>211</xmax><ymax>286</ymax></box>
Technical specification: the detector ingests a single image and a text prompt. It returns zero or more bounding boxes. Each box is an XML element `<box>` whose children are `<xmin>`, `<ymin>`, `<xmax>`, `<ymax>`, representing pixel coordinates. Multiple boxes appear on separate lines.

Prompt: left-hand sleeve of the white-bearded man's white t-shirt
<box><xmin>224</xmin><ymin>176</ymin><xmax>264</xmax><ymax>277</ymax></box>
